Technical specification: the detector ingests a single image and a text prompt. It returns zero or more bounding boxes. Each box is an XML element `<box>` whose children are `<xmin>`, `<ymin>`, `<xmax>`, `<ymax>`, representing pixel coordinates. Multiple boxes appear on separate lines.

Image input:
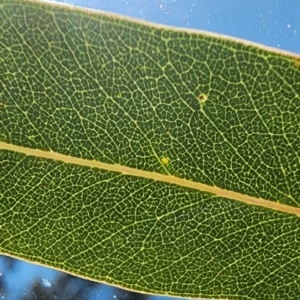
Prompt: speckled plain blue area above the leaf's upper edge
<box><xmin>55</xmin><ymin>0</ymin><xmax>300</xmax><ymax>53</ymax></box>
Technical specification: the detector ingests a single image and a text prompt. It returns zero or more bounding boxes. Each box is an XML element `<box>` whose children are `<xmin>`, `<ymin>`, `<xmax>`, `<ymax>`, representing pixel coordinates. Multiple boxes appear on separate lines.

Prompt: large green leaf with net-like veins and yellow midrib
<box><xmin>0</xmin><ymin>0</ymin><xmax>300</xmax><ymax>299</ymax></box>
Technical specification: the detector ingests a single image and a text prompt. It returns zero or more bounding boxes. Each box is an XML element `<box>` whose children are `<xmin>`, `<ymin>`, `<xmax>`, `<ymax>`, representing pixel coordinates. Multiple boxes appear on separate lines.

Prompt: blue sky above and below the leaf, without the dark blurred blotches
<box><xmin>0</xmin><ymin>0</ymin><xmax>300</xmax><ymax>300</ymax></box>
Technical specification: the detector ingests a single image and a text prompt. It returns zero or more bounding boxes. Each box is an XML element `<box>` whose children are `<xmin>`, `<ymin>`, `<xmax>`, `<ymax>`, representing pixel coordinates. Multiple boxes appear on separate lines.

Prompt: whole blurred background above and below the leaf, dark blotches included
<box><xmin>0</xmin><ymin>0</ymin><xmax>300</xmax><ymax>300</ymax></box>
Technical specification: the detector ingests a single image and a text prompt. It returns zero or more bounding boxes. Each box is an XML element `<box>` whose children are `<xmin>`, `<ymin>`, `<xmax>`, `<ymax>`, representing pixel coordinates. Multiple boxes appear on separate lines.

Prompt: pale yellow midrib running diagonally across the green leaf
<box><xmin>0</xmin><ymin>142</ymin><xmax>300</xmax><ymax>216</ymax></box>
